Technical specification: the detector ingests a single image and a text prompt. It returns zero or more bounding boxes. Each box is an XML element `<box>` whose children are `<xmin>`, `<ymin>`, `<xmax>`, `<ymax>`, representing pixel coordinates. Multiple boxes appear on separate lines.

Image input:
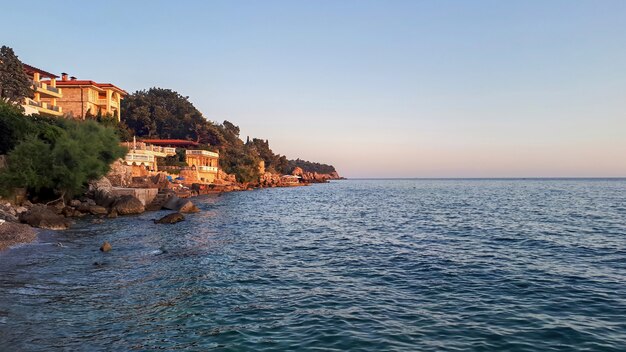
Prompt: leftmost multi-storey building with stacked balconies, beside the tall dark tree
<box><xmin>22</xmin><ymin>64</ymin><xmax>63</xmax><ymax>116</ymax></box>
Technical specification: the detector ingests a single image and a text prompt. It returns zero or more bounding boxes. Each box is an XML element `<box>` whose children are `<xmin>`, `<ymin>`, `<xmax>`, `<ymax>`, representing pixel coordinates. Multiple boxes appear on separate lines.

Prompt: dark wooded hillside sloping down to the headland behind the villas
<box><xmin>122</xmin><ymin>88</ymin><xmax>335</xmax><ymax>182</ymax></box>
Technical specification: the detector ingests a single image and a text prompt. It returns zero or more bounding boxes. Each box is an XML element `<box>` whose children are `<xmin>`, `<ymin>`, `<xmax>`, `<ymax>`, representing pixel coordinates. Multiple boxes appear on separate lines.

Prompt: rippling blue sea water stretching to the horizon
<box><xmin>0</xmin><ymin>180</ymin><xmax>626</xmax><ymax>351</ymax></box>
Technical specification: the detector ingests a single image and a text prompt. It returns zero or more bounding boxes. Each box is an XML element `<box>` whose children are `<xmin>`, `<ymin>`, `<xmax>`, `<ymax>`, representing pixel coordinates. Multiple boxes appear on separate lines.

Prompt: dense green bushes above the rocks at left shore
<box><xmin>0</xmin><ymin>103</ymin><xmax>126</xmax><ymax>200</ymax></box>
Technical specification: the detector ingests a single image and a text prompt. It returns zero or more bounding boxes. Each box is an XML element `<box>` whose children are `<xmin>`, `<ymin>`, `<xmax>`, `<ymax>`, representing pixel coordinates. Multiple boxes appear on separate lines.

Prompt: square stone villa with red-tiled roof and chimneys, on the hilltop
<box><xmin>46</xmin><ymin>73</ymin><xmax>128</xmax><ymax>121</ymax></box>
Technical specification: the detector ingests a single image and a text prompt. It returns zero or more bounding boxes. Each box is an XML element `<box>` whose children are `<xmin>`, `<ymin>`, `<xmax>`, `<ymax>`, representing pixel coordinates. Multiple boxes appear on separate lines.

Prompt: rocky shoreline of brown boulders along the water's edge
<box><xmin>0</xmin><ymin>170</ymin><xmax>343</xmax><ymax>251</ymax></box>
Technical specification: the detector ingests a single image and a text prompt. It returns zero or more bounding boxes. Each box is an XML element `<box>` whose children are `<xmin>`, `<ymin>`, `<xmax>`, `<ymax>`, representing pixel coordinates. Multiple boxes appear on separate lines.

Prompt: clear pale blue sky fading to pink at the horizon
<box><xmin>0</xmin><ymin>0</ymin><xmax>626</xmax><ymax>177</ymax></box>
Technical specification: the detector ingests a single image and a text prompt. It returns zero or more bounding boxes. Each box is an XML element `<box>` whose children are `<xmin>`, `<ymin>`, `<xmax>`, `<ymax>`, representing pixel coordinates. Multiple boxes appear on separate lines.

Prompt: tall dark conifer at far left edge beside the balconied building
<box><xmin>0</xmin><ymin>45</ymin><xmax>34</xmax><ymax>104</ymax></box>
